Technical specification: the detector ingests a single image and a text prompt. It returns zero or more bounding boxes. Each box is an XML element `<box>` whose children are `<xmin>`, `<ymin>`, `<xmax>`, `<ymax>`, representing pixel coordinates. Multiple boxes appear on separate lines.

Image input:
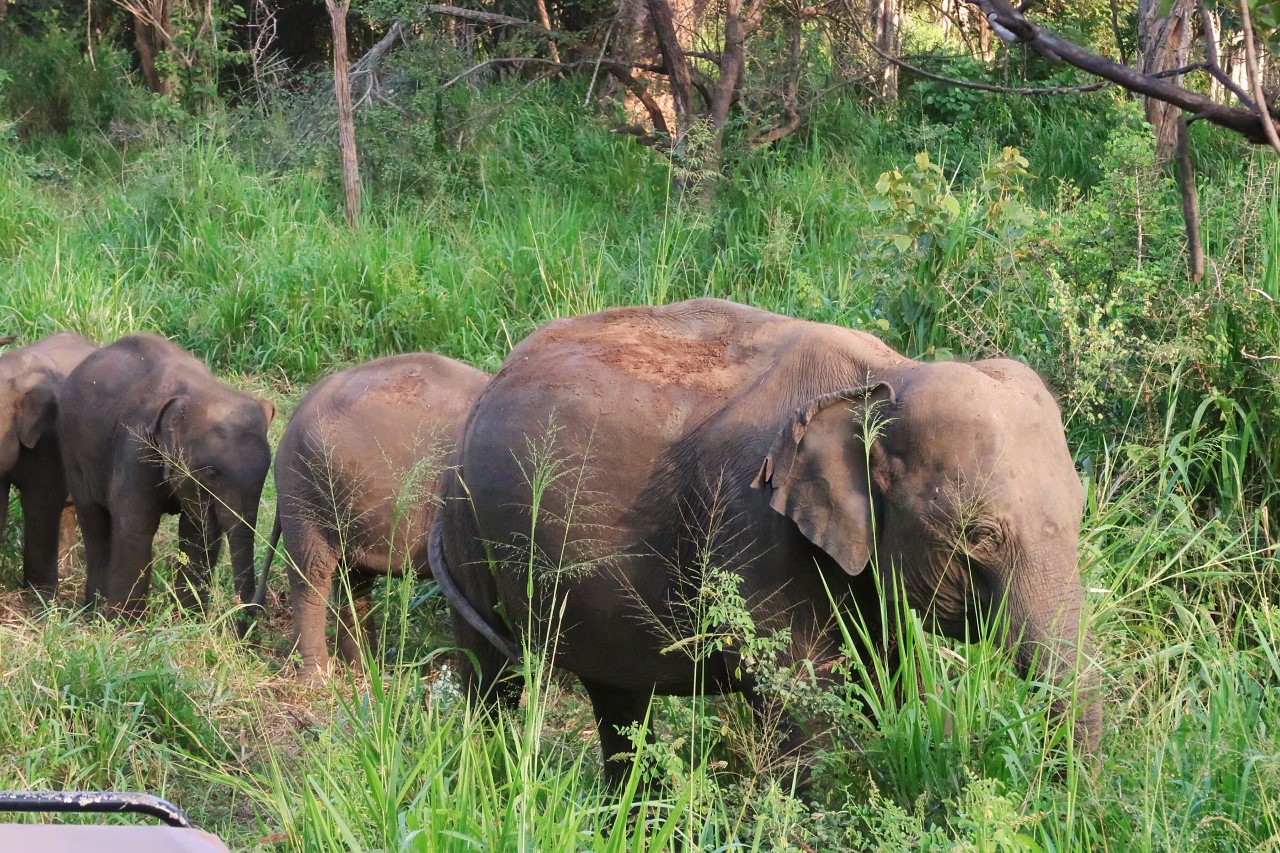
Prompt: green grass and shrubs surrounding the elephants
<box><xmin>0</xmin><ymin>1</ymin><xmax>1280</xmax><ymax>850</ymax></box>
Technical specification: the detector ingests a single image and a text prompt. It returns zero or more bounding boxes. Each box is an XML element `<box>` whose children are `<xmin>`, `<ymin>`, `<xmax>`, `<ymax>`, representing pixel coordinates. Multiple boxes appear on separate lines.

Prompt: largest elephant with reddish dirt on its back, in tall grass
<box><xmin>429</xmin><ymin>298</ymin><xmax>1102</xmax><ymax>785</ymax></box>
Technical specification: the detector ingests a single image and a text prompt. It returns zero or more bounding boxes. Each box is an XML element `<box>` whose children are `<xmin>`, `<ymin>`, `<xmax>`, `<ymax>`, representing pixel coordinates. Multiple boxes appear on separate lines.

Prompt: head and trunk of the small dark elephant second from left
<box><xmin>147</xmin><ymin>389</ymin><xmax>275</xmax><ymax>605</ymax></box>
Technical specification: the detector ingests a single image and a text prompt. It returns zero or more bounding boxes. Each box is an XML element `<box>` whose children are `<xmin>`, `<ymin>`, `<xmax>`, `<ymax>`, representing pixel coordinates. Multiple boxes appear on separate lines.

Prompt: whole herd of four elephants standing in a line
<box><xmin>0</xmin><ymin>298</ymin><xmax>1102</xmax><ymax>784</ymax></box>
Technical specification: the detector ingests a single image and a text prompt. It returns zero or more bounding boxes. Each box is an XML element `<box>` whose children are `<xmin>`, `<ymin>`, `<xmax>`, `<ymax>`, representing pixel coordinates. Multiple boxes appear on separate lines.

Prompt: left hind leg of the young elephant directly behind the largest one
<box><xmin>283</xmin><ymin>523</ymin><xmax>338</xmax><ymax>681</ymax></box>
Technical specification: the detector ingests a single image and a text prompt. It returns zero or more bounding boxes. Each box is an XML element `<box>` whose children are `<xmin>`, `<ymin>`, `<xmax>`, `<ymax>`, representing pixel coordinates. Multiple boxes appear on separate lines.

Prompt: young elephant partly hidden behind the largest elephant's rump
<box><xmin>259</xmin><ymin>352</ymin><xmax>489</xmax><ymax>680</ymax></box>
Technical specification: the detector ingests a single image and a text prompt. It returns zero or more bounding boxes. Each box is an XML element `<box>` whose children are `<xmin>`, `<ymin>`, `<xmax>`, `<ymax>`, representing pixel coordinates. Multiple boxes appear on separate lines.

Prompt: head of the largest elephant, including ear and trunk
<box><xmin>758</xmin><ymin>360</ymin><xmax>1102</xmax><ymax>749</ymax></box>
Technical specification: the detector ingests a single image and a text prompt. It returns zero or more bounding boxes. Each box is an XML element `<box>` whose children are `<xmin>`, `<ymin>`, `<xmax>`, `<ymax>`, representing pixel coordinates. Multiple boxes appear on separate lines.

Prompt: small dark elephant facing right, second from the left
<box><xmin>58</xmin><ymin>334</ymin><xmax>275</xmax><ymax>617</ymax></box>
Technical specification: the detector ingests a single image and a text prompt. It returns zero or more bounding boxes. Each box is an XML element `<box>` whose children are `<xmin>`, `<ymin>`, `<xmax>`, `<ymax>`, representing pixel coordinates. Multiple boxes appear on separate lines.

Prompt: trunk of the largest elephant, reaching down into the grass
<box><xmin>1007</xmin><ymin>565</ymin><xmax>1102</xmax><ymax>753</ymax></box>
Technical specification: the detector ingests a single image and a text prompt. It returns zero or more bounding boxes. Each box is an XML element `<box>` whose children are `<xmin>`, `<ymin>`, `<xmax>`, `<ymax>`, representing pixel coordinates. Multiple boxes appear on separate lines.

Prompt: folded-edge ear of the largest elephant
<box><xmin>751</xmin><ymin>382</ymin><xmax>895</xmax><ymax>575</ymax></box>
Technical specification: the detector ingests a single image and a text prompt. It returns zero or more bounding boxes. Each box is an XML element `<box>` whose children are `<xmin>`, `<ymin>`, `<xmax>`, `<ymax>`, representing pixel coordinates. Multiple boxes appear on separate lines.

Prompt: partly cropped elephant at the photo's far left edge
<box><xmin>0</xmin><ymin>332</ymin><xmax>97</xmax><ymax>598</ymax></box>
